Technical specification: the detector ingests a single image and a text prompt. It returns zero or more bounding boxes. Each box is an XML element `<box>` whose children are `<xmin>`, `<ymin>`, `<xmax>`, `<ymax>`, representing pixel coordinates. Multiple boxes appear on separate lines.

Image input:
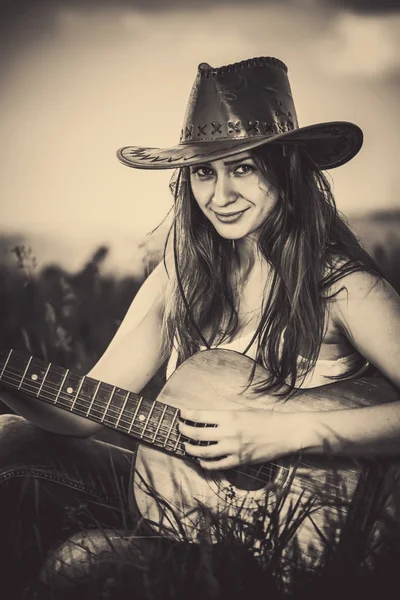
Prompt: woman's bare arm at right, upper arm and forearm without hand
<box><xmin>298</xmin><ymin>273</ymin><xmax>400</xmax><ymax>456</ymax></box>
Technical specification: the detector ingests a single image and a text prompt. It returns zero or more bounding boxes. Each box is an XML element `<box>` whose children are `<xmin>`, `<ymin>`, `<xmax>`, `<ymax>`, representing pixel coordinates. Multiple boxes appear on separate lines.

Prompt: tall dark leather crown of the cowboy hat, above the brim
<box><xmin>180</xmin><ymin>57</ymin><xmax>298</xmax><ymax>144</ymax></box>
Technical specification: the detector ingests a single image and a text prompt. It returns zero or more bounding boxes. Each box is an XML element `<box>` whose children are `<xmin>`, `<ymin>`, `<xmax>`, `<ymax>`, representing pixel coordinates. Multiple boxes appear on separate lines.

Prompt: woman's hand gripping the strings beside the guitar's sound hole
<box><xmin>179</xmin><ymin>408</ymin><xmax>301</xmax><ymax>470</ymax></box>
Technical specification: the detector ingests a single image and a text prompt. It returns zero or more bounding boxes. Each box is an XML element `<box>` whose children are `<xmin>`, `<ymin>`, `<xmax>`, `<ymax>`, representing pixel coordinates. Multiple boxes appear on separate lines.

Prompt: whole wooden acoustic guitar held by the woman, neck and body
<box><xmin>0</xmin><ymin>349</ymin><xmax>400</xmax><ymax>557</ymax></box>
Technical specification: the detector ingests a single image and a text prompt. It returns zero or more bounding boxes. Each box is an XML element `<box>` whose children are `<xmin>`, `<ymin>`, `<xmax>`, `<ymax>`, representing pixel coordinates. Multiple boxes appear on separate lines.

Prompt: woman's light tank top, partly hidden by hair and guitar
<box><xmin>166</xmin><ymin>331</ymin><xmax>369</xmax><ymax>388</ymax></box>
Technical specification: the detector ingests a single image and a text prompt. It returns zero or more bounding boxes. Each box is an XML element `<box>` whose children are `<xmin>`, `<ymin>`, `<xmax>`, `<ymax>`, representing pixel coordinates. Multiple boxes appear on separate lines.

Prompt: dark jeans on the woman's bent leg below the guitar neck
<box><xmin>0</xmin><ymin>415</ymin><xmax>155</xmax><ymax>599</ymax></box>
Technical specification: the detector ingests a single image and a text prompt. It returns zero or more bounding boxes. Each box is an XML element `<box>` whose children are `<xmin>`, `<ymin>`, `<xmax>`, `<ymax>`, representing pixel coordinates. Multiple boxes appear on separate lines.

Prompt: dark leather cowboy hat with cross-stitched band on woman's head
<box><xmin>117</xmin><ymin>57</ymin><xmax>363</xmax><ymax>169</ymax></box>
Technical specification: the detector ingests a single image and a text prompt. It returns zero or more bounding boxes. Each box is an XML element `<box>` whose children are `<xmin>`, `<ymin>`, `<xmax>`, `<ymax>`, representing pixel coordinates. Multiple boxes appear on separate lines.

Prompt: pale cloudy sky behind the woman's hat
<box><xmin>0</xmin><ymin>0</ymin><xmax>400</xmax><ymax>271</ymax></box>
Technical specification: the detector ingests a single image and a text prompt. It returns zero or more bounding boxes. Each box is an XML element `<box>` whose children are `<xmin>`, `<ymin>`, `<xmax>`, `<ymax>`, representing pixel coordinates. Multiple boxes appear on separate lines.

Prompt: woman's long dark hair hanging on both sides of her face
<box><xmin>163</xmin><ymin>144</ymin><xmax>382</xmax><ymax>394</ymax></box>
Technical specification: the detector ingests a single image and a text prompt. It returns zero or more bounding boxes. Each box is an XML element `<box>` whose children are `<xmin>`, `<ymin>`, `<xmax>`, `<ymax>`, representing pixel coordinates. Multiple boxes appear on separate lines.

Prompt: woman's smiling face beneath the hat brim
<box><xmin>190</xmin><ymin>152</ymin><xmax>278</xmax><ymax>240</ymax></box>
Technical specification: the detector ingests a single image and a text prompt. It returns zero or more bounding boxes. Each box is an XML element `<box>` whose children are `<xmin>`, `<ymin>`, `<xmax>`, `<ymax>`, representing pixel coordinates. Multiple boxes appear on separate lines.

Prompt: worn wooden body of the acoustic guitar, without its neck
<box><xmin>134</xmin><ymin>349</ymin><xmax>398</xmax><ymax>557</ymax></box>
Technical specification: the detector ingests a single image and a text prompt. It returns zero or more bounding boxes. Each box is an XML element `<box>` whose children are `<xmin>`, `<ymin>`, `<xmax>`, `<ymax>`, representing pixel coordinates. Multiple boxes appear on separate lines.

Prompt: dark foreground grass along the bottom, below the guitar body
<box><xmin>21</xmin><ymin>454</ymin><xmax>400</xmax><ymax>600</ymax></box>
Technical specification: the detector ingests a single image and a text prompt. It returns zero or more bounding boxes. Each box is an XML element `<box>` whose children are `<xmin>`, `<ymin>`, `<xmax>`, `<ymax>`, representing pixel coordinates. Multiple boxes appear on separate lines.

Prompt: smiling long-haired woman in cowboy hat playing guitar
<box><xmin>0</xmin><ymin>57</ymin><xmax>400</xmax><ymax>596</ymax></box>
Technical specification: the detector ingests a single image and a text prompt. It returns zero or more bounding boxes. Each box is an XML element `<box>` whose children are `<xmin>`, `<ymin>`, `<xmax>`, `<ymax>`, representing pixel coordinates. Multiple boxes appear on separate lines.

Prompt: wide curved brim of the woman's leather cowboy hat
<box><xmin>117</xmin><ymin>121</ymin><xmax>363</xmax><ymax>170</ymax></box>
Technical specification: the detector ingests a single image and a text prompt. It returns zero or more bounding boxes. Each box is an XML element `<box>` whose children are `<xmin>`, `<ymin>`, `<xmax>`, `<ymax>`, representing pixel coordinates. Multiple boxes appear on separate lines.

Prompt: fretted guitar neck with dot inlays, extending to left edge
<box><xmin>0</xmin><ymin>350</ymin><xmax>186</xmax><ymax>456</ymax></box>
